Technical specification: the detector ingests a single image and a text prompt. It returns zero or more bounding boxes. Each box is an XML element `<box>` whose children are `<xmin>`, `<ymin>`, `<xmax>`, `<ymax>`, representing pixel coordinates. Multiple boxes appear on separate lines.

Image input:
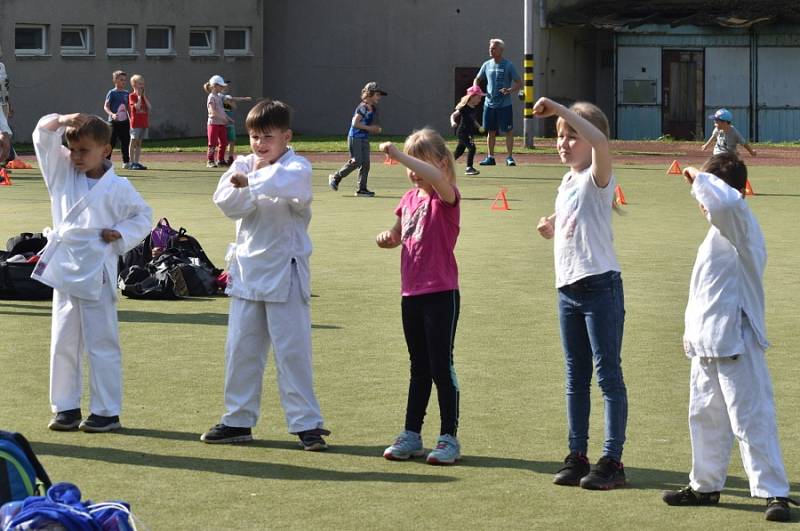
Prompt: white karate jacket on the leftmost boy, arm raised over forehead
<box><xmin>31</xmin><ymin>114</ymin><xmax>152</xmax><ymax>300</ymax></box>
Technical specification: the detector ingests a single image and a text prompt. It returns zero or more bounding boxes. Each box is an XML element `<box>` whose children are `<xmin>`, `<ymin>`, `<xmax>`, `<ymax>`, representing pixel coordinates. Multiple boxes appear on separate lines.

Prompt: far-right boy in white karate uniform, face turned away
<box><xmin>663</xmin><ymin>153</ymin><xmax>794</xmax><ymax>521</ymax></box>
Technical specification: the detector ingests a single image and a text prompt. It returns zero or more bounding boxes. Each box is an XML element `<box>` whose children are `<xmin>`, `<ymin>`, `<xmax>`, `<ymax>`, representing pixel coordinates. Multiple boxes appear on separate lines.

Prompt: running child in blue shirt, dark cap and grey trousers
<box><xmin>328</xmin><ymin>81</ymin><xmax>388</xmax><ymax>197</ymax></box>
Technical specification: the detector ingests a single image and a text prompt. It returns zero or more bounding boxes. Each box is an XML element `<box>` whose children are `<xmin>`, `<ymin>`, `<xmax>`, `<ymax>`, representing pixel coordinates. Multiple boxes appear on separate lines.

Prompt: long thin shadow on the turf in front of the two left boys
<box><xmin>32</xmin><ymin>438</ymin><xmax>456</xmax><ymax>483</ymax></box>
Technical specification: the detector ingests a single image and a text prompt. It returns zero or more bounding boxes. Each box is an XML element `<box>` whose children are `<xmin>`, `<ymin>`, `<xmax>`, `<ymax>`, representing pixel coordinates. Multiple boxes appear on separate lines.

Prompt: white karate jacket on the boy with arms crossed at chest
<box><xmin>213</xmin><ymin>149</ymin><xmax>312</xmax><ymax>302</ymax></box>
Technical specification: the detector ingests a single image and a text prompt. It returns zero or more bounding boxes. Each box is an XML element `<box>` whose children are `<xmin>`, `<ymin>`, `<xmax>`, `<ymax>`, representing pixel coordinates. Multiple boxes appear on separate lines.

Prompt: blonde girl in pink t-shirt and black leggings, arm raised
<box><xmin>376</xmin><ymin>129</ymin><xmax>461</xmax><ymax>465</ymax></box>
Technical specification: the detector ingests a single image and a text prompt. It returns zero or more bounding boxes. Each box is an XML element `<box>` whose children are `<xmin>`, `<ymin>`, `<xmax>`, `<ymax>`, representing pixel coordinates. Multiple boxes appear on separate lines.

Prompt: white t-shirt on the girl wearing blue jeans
<box><xmin>554</xmin><ymin>166</ymin><xmax>620</xmax><ymax>288</ymax></box>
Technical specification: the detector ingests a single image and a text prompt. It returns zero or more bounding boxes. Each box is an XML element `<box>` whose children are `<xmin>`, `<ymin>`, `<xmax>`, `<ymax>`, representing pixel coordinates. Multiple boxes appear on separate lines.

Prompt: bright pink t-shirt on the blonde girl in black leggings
<box><xmin>395</xmin><ymin>188</ymin><xmax>461</xmax><ymax>297</ymax></box>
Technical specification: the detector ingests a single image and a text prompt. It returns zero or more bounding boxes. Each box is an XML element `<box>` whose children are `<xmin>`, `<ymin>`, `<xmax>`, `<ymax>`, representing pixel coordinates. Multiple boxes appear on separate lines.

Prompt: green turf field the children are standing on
<box><xmin>0</xmin><ymin>159</ymin><xmax>800</xmax><ymax>530</ymax></box>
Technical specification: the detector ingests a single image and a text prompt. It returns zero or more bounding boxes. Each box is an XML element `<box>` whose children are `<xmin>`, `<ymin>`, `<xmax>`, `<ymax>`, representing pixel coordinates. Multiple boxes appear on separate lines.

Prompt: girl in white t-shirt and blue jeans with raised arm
<box><xmin>533</xmin><ymin>98</ymin><xmax>628</xmax><ymax>490</ymax></box>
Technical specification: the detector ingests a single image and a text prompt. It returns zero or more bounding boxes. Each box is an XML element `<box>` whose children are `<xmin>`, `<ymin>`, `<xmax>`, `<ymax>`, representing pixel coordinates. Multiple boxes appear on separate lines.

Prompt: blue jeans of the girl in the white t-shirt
<box><xmin>558</xmin><ymin>271</ymin><xmax>628</xmax><ymax>461</ymax></box>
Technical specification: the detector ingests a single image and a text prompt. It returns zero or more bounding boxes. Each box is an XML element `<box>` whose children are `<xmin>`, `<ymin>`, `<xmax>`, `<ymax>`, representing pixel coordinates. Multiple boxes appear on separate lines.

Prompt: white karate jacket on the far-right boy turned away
<box><xmin>683</xmin><ymin>173</ymin><xmax>769</xmax><ymax>358</ymax></box>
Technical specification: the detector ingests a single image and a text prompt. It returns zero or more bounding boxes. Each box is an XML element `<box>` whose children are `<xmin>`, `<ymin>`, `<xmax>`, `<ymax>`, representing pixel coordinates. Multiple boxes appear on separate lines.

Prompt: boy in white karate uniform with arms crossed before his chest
<box><xmin>200</xmin><ymin>100</ymin><xmax>330</xmax><ymax>451</ymax></box>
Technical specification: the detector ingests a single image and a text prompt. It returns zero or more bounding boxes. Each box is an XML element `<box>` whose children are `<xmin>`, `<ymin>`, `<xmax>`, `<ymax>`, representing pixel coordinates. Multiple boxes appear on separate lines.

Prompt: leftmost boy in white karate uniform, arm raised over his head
<box><xmin>31</xmin><ymin>114</ymin><xmax>152</xmax><ymax>432</ymax></box>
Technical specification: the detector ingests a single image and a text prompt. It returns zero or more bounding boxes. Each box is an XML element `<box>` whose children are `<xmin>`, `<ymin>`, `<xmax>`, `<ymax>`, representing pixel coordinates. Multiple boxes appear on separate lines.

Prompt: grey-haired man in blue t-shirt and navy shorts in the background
<box><xmin>472</xmin><ymin>39</ymin><xmax>522</xmax><ymax>166</ymax></box>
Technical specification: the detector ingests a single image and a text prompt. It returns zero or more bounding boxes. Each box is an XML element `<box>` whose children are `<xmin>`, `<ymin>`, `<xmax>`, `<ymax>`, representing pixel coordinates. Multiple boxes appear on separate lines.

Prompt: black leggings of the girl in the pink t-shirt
<box><xmin>401</xmin><ymin>290</ymin><xmax>461</xmax><ymax>437</ymax></box>
